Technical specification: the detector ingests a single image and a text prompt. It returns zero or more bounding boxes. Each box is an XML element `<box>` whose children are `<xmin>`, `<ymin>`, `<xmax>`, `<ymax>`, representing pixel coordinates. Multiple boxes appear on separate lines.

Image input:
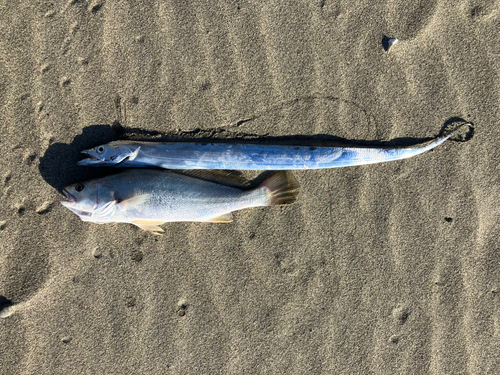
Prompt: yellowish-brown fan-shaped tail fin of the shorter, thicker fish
<box><xmin>260</xmin><ymin>171</ymin><xmax>300</xmax><ymax>206</ymax></box>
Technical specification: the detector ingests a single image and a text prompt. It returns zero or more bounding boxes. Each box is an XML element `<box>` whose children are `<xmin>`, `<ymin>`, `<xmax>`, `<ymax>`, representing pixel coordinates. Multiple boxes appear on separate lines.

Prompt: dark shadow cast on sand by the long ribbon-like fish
<box><xmin>39</xmin><ymin>117</ymin><xmax>474</xmax><ymax>191</ymax></box>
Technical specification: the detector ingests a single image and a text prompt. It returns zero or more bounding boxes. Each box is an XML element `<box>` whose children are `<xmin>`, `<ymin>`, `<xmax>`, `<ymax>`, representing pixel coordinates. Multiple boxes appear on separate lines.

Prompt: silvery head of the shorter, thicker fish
<box><xmin>61</xmin><ymin>180</ymin><xmax>115</xmax><ymax>222</ymax></box>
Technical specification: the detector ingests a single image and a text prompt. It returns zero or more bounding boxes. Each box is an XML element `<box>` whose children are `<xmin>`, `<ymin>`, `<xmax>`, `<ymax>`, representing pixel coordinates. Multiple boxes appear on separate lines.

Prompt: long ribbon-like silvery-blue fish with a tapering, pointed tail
<box><xmin>78</xmin><ymin>124</ymin><xmax>468</xmax><ymax>170</ymax></box>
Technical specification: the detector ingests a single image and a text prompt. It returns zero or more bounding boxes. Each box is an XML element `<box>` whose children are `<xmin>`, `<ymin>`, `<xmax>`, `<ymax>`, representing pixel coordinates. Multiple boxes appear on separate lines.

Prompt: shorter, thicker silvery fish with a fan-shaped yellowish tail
<box><xmin>61</xmin><ymin>169</ymin><xmax>299</xmax><ymax>234</ymax></box>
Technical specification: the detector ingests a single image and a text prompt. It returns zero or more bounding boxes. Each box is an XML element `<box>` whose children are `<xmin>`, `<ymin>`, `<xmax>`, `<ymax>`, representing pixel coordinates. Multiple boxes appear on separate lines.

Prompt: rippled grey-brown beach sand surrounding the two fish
<box><xmin>0</xmin><ymin>0</ymin><xmax>500</xmax><ymax>375</ymax></box>
